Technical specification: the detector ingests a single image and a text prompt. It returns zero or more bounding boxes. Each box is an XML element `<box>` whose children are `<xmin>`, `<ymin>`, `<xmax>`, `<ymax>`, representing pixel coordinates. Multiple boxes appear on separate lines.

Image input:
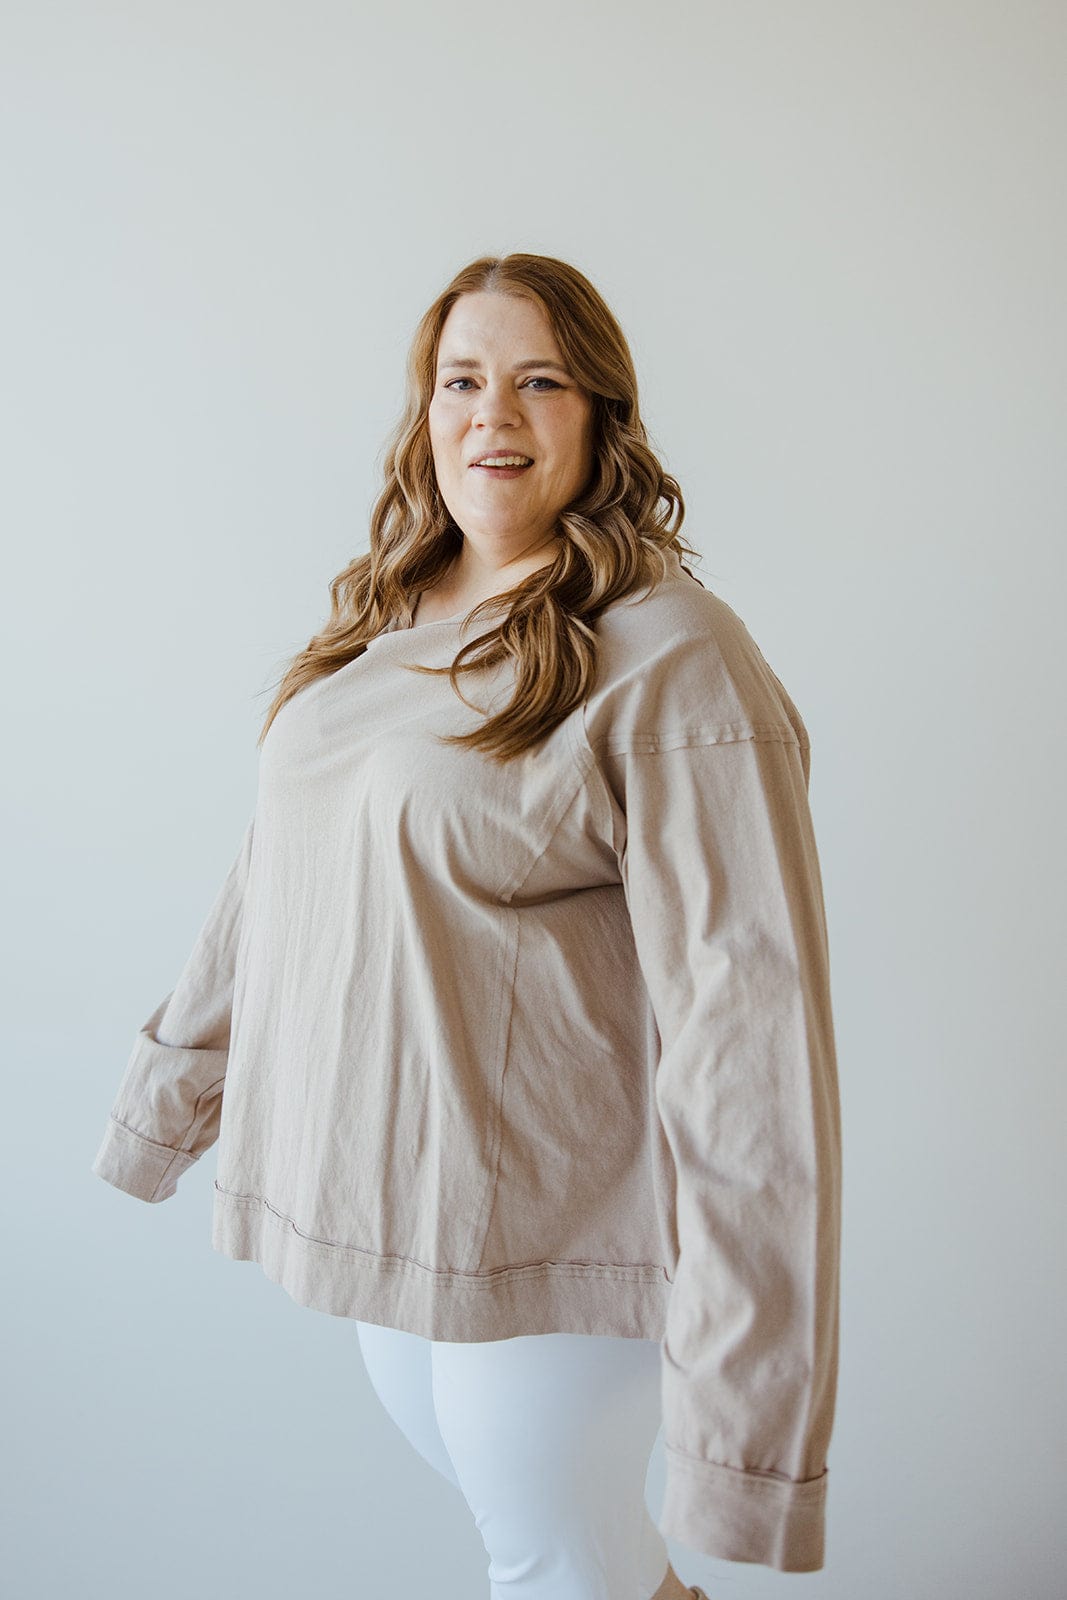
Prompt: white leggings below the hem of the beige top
<box><xmin>357</xmin><ymin>1322</ymin><xmax>669</xmax><ymax>1600</ymax></box>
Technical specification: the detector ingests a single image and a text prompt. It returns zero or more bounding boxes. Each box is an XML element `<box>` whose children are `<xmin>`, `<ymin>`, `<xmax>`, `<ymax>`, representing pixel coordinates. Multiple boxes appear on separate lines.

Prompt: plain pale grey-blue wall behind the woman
<box><xmin>0</xmin><ymin>0</ymin><xmax>1067</xmax><ymax>1600</ymax></box>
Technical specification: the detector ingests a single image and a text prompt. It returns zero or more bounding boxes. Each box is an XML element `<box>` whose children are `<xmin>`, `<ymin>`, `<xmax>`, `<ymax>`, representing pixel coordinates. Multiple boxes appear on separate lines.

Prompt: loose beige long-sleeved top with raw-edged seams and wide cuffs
<box><xmin>93</xmin><ymin>552</ymin><xmax>841</xmax><ymax>1571</ymax></box>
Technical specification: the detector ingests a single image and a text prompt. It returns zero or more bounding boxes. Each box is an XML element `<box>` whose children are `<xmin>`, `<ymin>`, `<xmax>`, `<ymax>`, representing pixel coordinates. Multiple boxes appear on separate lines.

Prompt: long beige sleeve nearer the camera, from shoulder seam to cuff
<box><xmin>603</xmin><ymin>720</ymin><xmax>841</xmax><ymax>1571</ymax></box>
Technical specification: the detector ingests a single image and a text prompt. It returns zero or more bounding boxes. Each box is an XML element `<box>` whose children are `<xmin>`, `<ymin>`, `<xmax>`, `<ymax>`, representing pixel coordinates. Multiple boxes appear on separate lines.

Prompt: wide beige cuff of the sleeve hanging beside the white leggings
<box><xmin>659</xmin><ymin>1445</ymin><xmax>829</xmax><ymax>1573</ymax></box>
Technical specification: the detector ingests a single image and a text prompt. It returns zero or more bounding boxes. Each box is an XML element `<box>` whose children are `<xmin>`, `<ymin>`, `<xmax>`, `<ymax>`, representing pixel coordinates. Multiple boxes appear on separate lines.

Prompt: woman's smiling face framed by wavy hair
<box><xmin>427</xmin><ymin>293</ymin><xmax>593</xmax><ymax>565</ymax></box>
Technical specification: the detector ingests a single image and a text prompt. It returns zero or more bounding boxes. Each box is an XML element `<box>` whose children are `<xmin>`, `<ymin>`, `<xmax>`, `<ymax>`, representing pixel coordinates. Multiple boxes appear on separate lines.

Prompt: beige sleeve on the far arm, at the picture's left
<box><xmin>91</xmin><ymin>818</ymin><xmax>254</xmax><ymax>1200</ymax></box>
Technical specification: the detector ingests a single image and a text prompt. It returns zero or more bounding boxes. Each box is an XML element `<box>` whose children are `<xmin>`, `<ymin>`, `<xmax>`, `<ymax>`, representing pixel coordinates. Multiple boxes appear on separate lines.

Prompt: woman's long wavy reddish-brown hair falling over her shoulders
<box><xmin>256</xmin><ymin>254</ymin><xmax>699</xmax><ymax>762</ymax></box>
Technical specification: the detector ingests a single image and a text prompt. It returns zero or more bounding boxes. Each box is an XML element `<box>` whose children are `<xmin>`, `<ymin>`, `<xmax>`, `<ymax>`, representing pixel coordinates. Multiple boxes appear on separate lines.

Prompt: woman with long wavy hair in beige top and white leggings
<box><xmin>93</xmin><ymin>254</ymin><xmax>840</xmax><ymax>1600</ymax></box>
